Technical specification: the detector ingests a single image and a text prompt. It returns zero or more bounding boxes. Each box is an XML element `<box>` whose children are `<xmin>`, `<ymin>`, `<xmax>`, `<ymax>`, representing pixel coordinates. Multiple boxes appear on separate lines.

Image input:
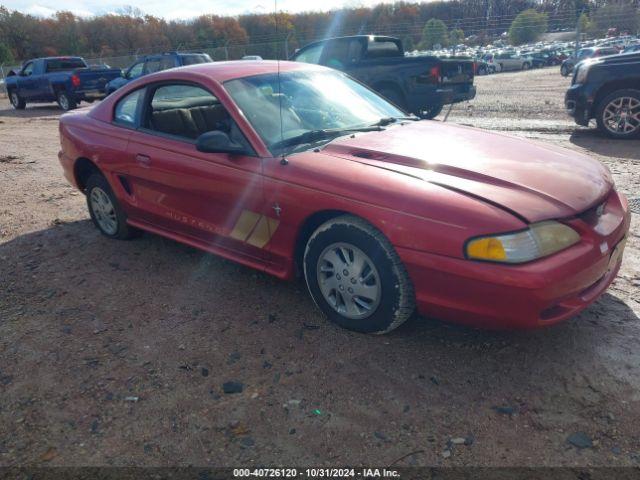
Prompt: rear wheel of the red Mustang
<box><xmin>85</xmin><ymin>173</ymin><xmax>139</xmax><ymax>240</ymax></box>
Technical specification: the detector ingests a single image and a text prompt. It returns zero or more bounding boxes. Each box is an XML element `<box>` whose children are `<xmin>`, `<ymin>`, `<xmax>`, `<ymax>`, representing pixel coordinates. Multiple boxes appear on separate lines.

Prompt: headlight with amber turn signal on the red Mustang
<box><xmin>466</xmin><ymin>221</ymin><xmax>580</xmax><ymax>263</ymax></box>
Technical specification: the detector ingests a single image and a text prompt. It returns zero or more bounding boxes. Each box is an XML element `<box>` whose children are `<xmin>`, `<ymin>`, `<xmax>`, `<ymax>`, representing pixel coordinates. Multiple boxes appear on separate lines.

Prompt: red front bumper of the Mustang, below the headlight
<box><xmin>397</xmin><ymin>192</ymin><xmax>630</xmax><ymax>329</ymax></box>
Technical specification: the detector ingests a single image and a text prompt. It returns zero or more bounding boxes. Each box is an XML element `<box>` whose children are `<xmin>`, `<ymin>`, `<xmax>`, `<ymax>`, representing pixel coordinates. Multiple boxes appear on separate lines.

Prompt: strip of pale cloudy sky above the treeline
<box><xmin>1</xmin><ymin>0</ymin><xmax>404</xmax><ymax>20</ymax></box>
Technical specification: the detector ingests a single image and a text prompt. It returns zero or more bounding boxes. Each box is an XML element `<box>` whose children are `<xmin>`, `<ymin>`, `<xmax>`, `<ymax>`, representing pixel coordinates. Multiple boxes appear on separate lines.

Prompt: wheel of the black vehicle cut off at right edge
<box><xmin>596</xmin><ymin>89</ymin><xmax>640</xmax><ymax>139</ymax></box>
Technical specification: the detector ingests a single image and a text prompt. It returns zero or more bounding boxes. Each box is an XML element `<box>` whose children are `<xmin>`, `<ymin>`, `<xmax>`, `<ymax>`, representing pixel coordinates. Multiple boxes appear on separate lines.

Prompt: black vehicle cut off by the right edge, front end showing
<box><xmin>565</xmin><ymin>52</ymin><xmax>640</xmax><ymax>138</ymax></box>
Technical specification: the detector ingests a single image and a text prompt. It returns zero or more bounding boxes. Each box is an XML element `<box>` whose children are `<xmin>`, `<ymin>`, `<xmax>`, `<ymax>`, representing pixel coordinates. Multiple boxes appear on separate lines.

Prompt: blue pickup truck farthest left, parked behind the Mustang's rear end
<box><xmin>6</xmin><ymin>57</ymin><xmax>121</xmax><ymax>111</ymax></box>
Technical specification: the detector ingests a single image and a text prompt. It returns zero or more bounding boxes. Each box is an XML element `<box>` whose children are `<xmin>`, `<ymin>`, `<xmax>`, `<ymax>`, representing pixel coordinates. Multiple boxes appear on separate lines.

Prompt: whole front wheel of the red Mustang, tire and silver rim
<box><xmin>304</xmin><ymin>215</ymin><xmax>415</xmax><ymax>333</ymax></box>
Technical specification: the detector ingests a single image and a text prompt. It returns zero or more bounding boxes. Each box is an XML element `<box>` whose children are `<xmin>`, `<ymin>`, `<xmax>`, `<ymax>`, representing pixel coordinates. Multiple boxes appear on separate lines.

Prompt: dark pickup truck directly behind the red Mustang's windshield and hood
<box><xmin>291</xmin><ymin>35</ymin><xmax>476</xmax><ymax>118</ymax></box>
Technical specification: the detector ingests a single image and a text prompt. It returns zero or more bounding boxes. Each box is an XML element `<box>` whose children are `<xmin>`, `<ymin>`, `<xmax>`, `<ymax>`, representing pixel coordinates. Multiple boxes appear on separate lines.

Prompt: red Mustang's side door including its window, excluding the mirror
<box><xmin>127</xmin><ymin>83</ymin><xmax>272</xmax><ymax>261</ymax></box>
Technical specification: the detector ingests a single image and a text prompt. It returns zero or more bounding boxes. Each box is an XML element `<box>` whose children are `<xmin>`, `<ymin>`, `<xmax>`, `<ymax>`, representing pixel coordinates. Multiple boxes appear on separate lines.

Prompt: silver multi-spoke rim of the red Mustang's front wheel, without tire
<box><xmin>317</xmin><ymin>243</ymin><xmax>382</xmax><ymax>319</ymax></box>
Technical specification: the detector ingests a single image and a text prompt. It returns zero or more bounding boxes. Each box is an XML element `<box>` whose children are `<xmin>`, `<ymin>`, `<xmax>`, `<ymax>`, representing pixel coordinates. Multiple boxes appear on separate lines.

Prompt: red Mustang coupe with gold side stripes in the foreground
<box><xmin>59</xmin><ymin>61</ymin><xmax>630</xmax><ymax>333</ymax></box>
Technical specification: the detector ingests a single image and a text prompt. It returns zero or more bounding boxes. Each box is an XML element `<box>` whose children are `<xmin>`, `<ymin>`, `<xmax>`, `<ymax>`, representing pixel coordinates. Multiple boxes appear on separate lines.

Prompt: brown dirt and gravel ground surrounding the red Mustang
<box><xmin>0</xmin><ymin>68</ymin><xmax>640</xmax><ymax>466</ymax></box>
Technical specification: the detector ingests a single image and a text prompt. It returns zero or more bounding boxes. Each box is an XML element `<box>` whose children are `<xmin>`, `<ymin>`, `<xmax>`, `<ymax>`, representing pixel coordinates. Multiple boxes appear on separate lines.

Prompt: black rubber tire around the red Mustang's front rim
<box><xmin>304</xmin><ymin>215</ymin><xmax>415</xmax><ymax>334</ymax></box>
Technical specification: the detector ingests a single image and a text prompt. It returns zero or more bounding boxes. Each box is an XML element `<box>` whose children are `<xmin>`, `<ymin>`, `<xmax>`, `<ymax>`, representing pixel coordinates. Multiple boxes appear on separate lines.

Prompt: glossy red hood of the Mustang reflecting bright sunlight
<box><xmin>323</xmin><ymin>121</ymin><xmax>613</xmax><ymax>222</ymax></box>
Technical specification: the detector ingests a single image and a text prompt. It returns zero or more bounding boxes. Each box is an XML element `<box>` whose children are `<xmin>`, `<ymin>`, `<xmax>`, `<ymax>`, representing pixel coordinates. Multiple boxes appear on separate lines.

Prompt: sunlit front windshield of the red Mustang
<box><xmin>225</xmin><ymin>71</ymin><xmax>405</xmax><ymax>153</ymax></box>
